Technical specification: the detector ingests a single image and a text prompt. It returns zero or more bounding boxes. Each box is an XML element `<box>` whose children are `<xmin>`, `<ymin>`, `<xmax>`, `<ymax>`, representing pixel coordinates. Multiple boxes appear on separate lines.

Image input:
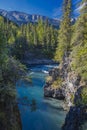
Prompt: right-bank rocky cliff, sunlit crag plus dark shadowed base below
<box><xmin>44</xmin><ymin>53</ymin><xmax>87</xmax><ymax>130</ymax></box>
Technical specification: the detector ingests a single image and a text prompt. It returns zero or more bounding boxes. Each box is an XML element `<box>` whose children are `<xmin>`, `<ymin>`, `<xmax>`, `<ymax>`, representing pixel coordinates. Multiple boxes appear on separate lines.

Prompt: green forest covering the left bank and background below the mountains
<box><xmin>0</xmin><ymin>13</ymin><xmax>58</xmax><ymax>96</ymax></box>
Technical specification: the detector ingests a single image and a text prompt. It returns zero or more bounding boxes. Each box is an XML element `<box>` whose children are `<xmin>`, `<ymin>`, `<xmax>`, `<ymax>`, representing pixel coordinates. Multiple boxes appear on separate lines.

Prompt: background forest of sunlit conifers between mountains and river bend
<box><xmin>0</xmin><ymin>17</ymin><xmax>58</xmax><ymax>59</ymax></box>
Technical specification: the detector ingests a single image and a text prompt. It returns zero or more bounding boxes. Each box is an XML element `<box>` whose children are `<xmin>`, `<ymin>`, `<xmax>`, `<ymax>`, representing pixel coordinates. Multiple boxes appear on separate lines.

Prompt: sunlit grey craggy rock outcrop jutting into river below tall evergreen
<box><xmin>44</xmin><ymin>57</ymin><xmax>81</xmax><ymax>107</ymax></box>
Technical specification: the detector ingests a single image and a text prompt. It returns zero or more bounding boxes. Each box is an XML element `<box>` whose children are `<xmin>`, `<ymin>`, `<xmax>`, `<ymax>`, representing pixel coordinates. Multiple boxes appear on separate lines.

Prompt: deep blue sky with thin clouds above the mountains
<box><xmin>0</xmin><ymin>0</ymin><xmax>80</xmax><ymax>18</ymax></box>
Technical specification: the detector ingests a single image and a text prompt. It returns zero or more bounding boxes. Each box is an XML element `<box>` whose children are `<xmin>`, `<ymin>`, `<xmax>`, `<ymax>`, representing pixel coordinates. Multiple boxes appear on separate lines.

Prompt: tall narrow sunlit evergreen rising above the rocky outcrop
<box><xmin>55</xmin><ymin>0</ymin><xmax>72</xmax><ymax>61</ymax></box>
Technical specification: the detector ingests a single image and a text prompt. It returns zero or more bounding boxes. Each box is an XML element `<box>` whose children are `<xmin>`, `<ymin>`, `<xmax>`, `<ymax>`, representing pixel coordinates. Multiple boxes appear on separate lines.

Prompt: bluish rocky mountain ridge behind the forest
<box><xmin>0</xmin><ymin>9</ymin><xmax>60</xmax><ymax>27</ymax></box>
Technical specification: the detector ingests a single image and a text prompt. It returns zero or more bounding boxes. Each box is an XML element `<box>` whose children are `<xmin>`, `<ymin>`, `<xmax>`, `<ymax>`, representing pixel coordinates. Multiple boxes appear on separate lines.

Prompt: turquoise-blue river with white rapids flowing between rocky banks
<box><xmin>17</xmin><ymin>65</ymin><xmax>66</xmax><ymax>130</ymax></box>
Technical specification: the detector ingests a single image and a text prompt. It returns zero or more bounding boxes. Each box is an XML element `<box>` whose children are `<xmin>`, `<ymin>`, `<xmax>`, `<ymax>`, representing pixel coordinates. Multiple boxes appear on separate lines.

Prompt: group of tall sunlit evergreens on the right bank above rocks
<box><xmin>55</xmin><ymin>0</ymin><xmax>87</xmax><ymax>104</ymax></box>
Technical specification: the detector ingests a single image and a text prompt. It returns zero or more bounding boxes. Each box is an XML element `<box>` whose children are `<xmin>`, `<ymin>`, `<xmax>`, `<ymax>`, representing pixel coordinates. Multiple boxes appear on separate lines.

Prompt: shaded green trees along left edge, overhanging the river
<box><xmin>0</xmin><ymin>17</ymin><xmax>25</xmax><ymax>102</ymax></box>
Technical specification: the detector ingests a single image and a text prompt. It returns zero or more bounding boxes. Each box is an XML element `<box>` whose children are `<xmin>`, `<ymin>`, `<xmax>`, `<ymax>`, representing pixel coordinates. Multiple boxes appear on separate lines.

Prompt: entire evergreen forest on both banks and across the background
<box><xmin>0</xmin><ymin>0</ymin><xmax>87</xmax><ymax>130</ymax></box>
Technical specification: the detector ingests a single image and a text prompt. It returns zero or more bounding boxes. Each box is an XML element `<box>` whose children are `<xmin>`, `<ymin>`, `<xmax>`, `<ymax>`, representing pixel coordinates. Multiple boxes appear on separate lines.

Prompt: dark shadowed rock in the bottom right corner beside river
<box><xmin>62</xmin><ymin>107</ymin><xmax>87</xmax><ymax>130</ymax></box>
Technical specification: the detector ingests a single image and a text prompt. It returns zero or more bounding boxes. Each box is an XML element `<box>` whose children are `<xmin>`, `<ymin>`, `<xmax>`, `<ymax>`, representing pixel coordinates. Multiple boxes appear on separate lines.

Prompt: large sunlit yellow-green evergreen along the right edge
<box><xmin>71</xmin><ymin>0</ymin><xmax>87</xmax><ymax>80</ymax></box>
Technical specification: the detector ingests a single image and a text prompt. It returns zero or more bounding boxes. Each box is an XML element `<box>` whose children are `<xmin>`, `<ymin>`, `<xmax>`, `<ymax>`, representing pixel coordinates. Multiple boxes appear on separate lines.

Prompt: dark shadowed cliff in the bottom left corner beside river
<box><xmin>0</xmin><ymin>99</ymin><xmax>22</xmax><ymax>130</ymax></box>
